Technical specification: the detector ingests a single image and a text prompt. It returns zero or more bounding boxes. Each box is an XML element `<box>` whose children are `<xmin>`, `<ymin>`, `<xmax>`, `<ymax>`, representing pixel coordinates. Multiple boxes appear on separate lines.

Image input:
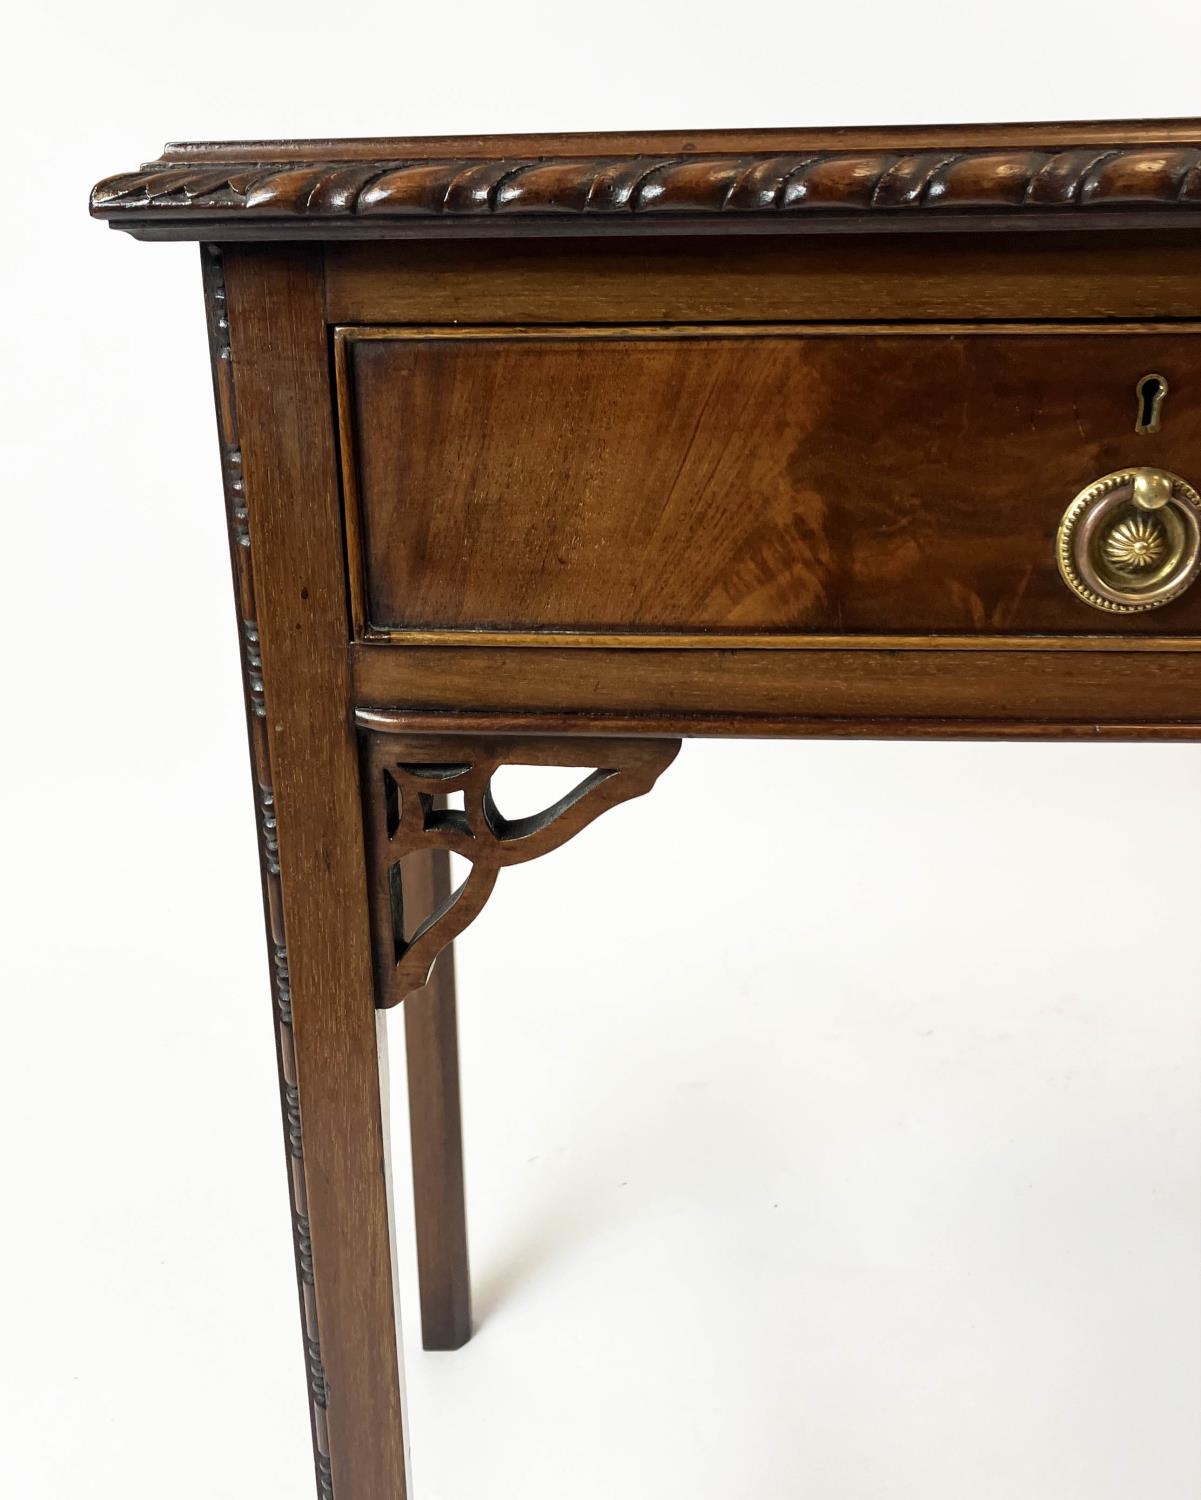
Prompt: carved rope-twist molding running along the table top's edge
<box><xmin>91</xmin><ymin>146</ymin><xmax>1201</xmax><ymax>221</ymax></box>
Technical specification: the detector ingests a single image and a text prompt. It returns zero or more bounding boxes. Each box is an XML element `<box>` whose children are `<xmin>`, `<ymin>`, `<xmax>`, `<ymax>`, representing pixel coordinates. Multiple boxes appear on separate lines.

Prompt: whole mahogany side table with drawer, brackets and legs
<box><xmin>91</xmin><ymin>120</ymin><xmax>1201</xmax><ymax>1500</ymax></box>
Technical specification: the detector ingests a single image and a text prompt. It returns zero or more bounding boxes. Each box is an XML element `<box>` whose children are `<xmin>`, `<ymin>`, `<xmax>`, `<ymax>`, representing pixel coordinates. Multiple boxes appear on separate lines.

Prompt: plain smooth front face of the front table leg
<box><xmin>226</xmin><ymin>249</ymin><xmax>406</xmax><ymax>1500</ymax></box>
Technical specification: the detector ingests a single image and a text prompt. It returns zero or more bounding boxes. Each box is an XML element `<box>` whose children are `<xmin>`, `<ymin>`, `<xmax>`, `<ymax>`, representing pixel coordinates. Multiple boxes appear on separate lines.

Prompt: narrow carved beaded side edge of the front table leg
<box><xmin>202</xmin><ymin>245</ymin><xmax>333</xmax><ymax>1500</ymax></box>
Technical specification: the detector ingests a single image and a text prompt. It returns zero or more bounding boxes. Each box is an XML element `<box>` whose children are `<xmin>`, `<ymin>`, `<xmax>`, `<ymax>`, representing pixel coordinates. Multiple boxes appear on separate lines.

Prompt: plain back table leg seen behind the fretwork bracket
<box><xmin>403</xmin><ymin>849</ymin><xmax>471</xmax><ymax>1349</ymax></box>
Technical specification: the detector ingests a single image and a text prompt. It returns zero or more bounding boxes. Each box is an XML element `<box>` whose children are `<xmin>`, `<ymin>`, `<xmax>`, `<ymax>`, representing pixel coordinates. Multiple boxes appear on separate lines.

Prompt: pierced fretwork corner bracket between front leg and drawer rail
<box><xmin>357</xmin><ymin>726</ymin><xmax>679</xmax><ymax>1008</ymax></box>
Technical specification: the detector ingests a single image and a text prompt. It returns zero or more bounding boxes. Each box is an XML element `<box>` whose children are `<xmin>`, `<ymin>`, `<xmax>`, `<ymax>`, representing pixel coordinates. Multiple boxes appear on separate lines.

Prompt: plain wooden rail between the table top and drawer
<box><xmin>325</xmin><ymin>230</ymin><xmax>1201</xmax><ymax>324</ymax></box>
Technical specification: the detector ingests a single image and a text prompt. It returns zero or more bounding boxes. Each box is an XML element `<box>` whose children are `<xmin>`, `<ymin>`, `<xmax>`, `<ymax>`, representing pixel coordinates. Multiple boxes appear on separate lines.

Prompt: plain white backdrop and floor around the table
<box><xmin>0</xmin><ymin>0</ymin><xmax>1201</xmax><ymax>1500</ymax></box>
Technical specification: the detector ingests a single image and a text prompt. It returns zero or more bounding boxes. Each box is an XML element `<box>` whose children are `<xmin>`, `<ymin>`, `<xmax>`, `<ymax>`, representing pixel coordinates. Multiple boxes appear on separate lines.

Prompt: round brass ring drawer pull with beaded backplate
<box><xmin>1057</xmin><ymin>468</ymin><xmax>1201</xmax><ymax>614</ymax></box>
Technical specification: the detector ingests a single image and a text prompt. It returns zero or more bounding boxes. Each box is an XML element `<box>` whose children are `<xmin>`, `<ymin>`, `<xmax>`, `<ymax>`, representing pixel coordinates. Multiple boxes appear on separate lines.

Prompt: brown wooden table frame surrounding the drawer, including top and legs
<box><xmin>93</xmin><ymin>122</ymin><xmax>1201</xmax><ymax>1500</ymax></box>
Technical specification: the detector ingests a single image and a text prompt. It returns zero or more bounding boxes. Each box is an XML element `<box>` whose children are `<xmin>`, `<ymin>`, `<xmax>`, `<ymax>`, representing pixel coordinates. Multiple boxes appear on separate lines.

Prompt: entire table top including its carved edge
<box><xmin>91</xmin><ymin>120</ymin><xmax>1201</xmax><ymax>240</ymax></box>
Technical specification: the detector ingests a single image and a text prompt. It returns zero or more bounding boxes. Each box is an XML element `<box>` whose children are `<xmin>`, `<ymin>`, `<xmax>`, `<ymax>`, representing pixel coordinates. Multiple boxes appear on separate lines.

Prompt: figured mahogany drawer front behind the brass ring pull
<box><xmin>337</xmin><ymin>327</ymin><xmax>1201</xmax><ymax>636</ymax></box>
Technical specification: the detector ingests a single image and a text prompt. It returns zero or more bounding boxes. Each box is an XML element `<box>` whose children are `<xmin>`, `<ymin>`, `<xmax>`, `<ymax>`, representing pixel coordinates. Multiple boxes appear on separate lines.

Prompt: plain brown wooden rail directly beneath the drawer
<box><xmin>351</xmin><ymin>645</ymin><xmax>1201</xmax><ymax>735</ymax></box>
